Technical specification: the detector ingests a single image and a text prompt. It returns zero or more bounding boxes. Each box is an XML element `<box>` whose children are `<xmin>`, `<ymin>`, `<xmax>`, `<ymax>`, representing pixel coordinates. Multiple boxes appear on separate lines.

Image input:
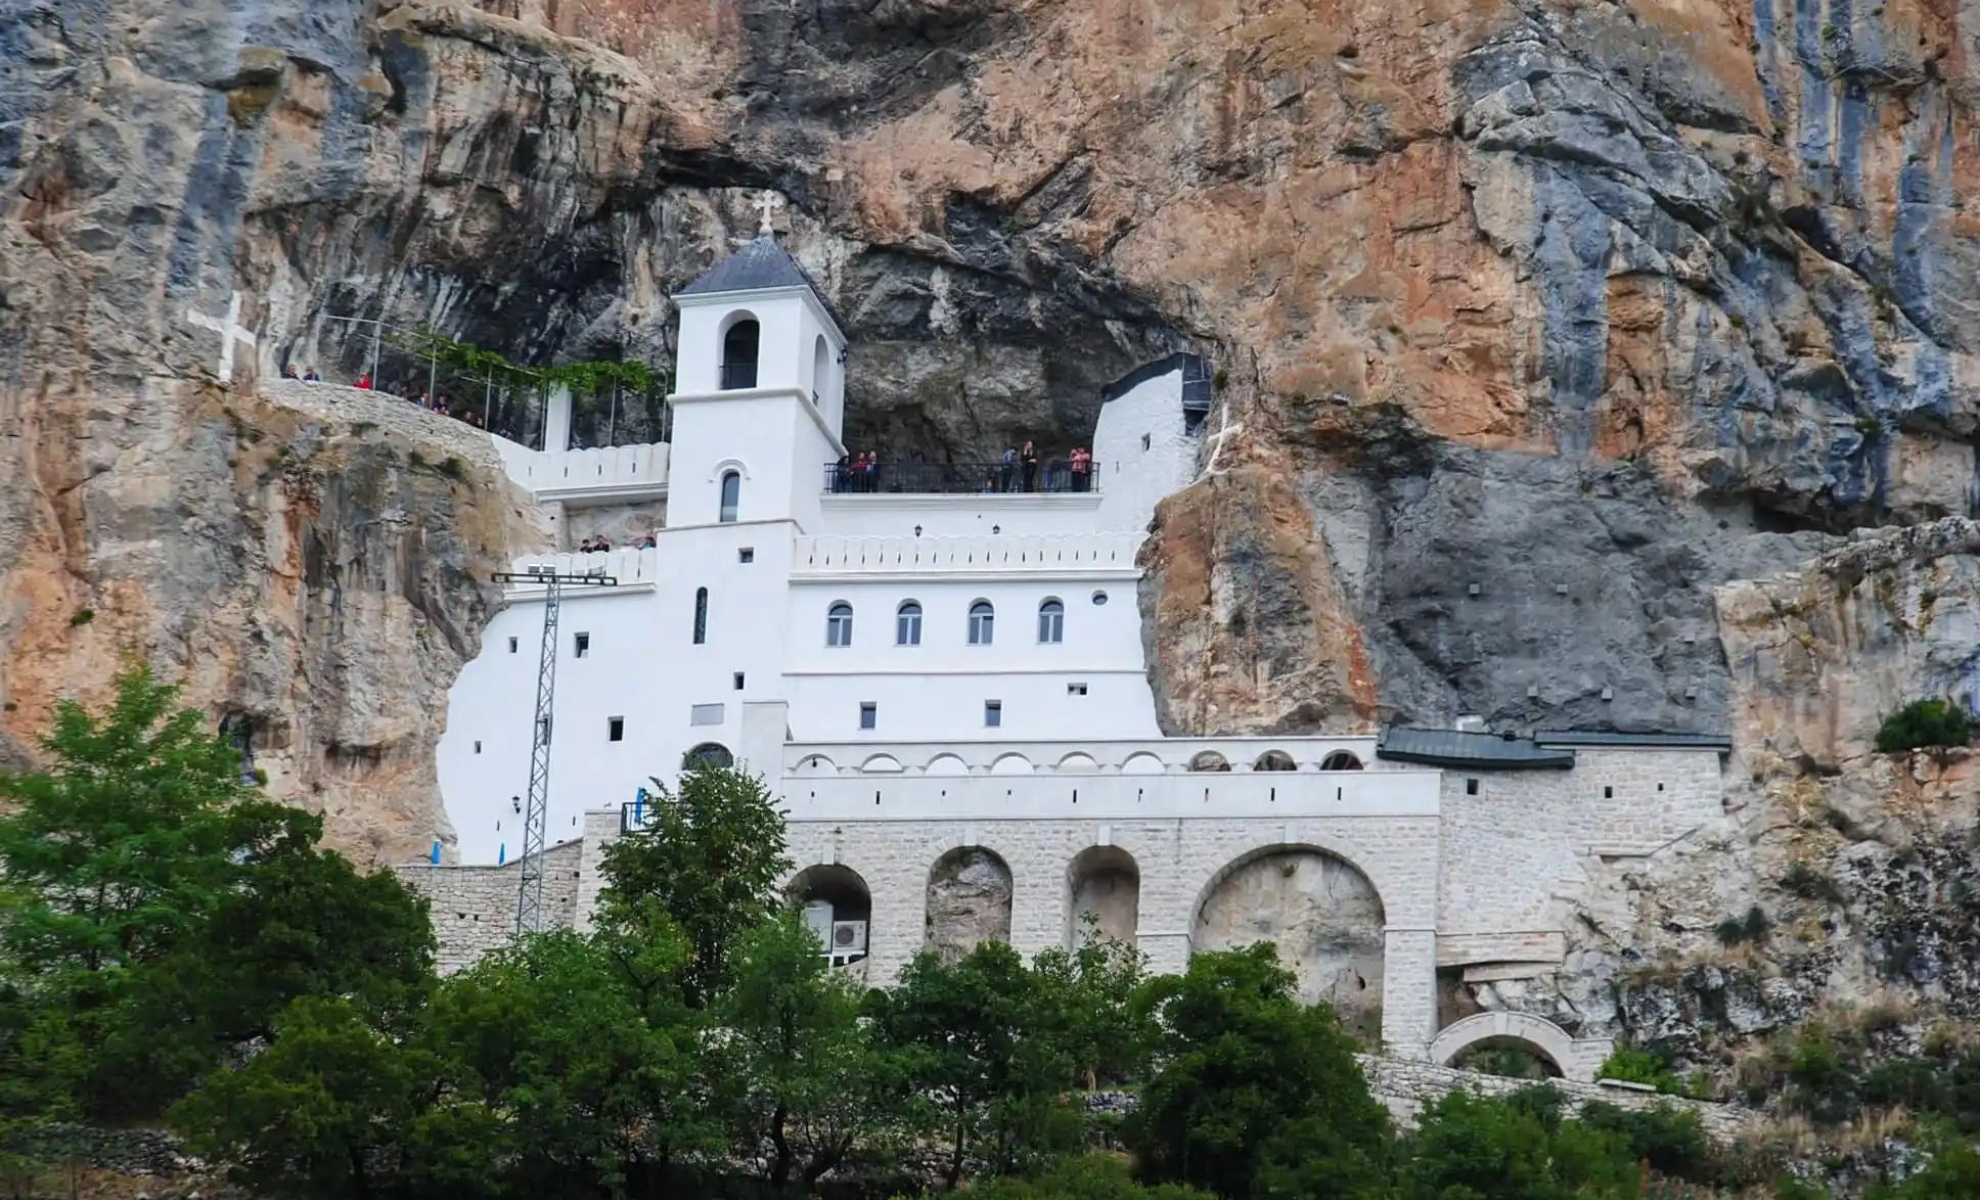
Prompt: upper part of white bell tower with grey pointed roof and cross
<box><xmin>667</xmin><ymin>200</ymin><xmax>845</xmax><ymax>527</ymax></box>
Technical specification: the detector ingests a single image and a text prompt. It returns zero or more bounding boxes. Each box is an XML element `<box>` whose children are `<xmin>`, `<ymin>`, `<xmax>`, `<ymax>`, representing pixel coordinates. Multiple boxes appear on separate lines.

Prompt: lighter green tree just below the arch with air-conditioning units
<box><xmin>715</xmin><ymin>911</ymin><xmax>909</xmax><ymax>1188</ymax></box>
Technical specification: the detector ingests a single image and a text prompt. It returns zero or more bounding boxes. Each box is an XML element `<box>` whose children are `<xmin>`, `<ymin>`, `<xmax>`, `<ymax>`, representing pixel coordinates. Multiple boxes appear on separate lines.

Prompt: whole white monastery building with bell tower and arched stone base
<box><xmin>406</xmin><ymin>234</ymin><xmax>1729</xmax><ymax>1079</ymax></box>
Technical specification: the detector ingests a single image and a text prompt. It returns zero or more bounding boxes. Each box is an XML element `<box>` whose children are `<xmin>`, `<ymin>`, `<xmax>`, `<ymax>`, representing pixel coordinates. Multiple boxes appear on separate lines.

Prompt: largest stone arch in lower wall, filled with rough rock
<box><xmin>1190</xmin><ymin>844</ymin><xmax>1388</xmax><ymax>1040</ymax></box>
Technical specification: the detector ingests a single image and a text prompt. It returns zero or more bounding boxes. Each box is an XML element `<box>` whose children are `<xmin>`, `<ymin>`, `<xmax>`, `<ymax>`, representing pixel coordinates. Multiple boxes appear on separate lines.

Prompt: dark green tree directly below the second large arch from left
<box><xmin>867</xmin><ymin>943</ymin><xmax>1081</xmax><ymax>1188</ymax></box>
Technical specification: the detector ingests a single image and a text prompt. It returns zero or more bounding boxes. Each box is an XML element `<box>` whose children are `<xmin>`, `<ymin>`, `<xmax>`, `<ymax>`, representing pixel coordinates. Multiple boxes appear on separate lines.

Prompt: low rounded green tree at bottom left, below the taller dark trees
<box><xmin>172</xmin><ymin>996</ymin><xmax>436</xmax><ymax>1200</ymax></box>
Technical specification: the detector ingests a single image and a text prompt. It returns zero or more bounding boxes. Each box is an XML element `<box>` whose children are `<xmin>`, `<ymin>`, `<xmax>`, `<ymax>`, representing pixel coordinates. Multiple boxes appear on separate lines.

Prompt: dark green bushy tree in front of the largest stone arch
<box><xmin>1127</xmin><ymin>943</ymin><xmax>1388</xmax><ymax>1198</ymax></box>
